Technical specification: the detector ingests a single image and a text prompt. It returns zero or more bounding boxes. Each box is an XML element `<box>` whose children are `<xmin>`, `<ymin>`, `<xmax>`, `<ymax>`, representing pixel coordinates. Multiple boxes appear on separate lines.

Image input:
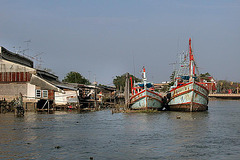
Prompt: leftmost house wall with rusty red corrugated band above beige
<box><xmin>0</xmin><ymin>59</ymin><xmax>36</xmax><ymax>102</ymax></box>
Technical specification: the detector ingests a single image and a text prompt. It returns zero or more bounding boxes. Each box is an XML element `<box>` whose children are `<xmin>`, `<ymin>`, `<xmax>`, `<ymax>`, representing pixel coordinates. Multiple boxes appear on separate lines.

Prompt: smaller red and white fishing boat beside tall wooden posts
<box><xmin>130</xmin><ymin>67</ymin><xmax>163</xmax><ymax>110</ymax></box>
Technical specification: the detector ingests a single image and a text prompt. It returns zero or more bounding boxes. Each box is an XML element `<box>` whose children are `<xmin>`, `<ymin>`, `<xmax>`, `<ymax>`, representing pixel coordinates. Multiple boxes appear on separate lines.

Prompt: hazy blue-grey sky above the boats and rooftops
<box><xmin>0</xmin><ymin>0</ymin><xmax>240</xmax><ymax>84</ymax></box>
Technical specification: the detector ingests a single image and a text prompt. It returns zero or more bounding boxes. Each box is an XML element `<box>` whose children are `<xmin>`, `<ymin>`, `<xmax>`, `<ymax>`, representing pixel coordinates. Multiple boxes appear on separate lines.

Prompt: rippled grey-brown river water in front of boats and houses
<box><xmin>0</xmin><ymin>100</ymin><xmax>240</xmax><ymax>160</ymax></box>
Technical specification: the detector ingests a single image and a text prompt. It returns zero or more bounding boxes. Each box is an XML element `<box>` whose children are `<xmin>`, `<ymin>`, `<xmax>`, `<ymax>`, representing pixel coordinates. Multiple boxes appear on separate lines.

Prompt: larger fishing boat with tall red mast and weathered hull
<box><xmin>167</xmin><ymin>38</ymin><xmax>209</xmax><ymax>112</ymax></box>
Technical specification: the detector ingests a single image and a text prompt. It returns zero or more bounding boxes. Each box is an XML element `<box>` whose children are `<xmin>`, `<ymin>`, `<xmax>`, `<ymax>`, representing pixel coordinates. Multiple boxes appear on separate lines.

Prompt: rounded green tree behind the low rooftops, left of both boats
<box><xmin>62</xmin><ymin>71</ymin><xmax>91</xmax><ymax>84</ymax></box>
